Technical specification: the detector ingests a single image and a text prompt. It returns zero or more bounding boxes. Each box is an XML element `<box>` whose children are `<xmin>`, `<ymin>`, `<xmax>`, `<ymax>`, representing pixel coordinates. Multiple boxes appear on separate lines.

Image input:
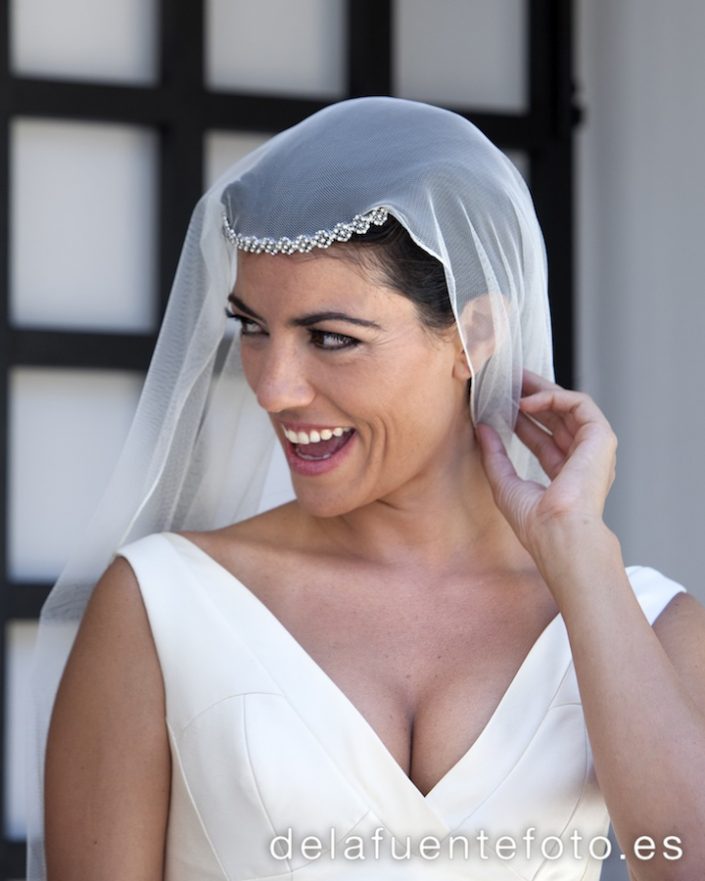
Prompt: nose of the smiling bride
<box><xmin>248</xmin><ymin>339</ymin><xmax>315</xmax><ymax>413</ymax></box>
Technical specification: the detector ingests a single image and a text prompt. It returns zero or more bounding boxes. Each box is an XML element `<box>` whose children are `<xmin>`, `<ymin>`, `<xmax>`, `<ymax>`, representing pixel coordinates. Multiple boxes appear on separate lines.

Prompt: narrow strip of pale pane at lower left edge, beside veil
<box><xmin>5</xmin><ymin>621</ymin><xmax>37</xmax><ymax>839</ymax></box>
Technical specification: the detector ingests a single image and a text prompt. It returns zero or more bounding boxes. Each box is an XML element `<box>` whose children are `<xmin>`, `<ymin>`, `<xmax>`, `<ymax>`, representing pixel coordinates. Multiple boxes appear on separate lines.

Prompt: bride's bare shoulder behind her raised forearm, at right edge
<box><xmin>653</xmin><ymin>592</ymin><xmax>705</xmax><ymax>713</ymax></box>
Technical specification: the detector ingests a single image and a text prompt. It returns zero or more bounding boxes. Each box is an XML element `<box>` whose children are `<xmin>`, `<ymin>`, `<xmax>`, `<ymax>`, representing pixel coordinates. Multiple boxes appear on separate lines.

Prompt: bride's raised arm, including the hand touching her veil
<box><xmin>476</xmin><ymin>371</ymin><xmax>705</xmax><ymax>881</ymax></box>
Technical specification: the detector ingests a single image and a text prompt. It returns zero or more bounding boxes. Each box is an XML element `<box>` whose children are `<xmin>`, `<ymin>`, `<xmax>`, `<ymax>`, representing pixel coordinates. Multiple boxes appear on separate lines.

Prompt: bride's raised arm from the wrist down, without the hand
<box><xmin>541</xmin><ymin>524</ymin><xmax>705</xmax><ymax>881</ymax></box>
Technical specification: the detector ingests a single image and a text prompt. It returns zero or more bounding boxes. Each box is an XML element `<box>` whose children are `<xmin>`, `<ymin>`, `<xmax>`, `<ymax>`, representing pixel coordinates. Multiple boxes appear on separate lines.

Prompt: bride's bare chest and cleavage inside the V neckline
<box><xmin>243</xmin><ymin>564</ymin><xmax>557</xmax><ymax>795</ymax></box>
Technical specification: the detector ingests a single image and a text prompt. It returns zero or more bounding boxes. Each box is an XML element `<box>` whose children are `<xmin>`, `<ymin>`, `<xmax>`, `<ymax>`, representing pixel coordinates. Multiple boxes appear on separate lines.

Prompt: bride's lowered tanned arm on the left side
<box><xmin>44</xmin><ymin>557</ymin><xmax>171</xmax><ymax>881</ymax></box>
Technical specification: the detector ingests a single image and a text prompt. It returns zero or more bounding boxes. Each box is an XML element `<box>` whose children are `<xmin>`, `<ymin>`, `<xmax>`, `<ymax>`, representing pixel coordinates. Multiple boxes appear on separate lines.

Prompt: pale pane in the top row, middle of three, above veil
<box><xmin>206</xmin><ymin>0</ymin><xmax>345</xmax><ymax>96</ymax></box>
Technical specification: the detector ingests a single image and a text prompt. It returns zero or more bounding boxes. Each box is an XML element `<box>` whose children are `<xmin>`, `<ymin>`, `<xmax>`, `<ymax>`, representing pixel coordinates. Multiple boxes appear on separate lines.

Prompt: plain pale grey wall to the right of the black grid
<box><xmin>577</xmin><ymin>0</ymin><xmax>705</xmax><ymax>601</ymax></box>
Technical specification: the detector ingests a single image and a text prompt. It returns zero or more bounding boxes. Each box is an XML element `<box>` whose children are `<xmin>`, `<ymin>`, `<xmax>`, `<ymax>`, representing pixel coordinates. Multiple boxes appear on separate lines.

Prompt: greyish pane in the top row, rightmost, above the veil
<box><xmin>394</xmin><ymin>0</ymin><xmax>528</xmax><ymax>111</ymax></box>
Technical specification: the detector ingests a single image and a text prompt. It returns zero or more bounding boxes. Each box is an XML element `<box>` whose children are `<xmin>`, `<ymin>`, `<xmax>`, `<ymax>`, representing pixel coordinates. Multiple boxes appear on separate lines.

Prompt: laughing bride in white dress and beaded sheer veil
<box><xmin>30</xmin><ymin>98</ymin><xmax>705</xmax><ymax>881</ymax></box>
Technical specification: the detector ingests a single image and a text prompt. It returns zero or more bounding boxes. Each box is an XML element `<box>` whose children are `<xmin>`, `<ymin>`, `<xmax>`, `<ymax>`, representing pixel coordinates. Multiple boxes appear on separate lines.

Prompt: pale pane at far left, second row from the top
<box><xmin>10</xmin><ymin>119</ymin><xmax>157</xmax><ymax>330</ymax></box>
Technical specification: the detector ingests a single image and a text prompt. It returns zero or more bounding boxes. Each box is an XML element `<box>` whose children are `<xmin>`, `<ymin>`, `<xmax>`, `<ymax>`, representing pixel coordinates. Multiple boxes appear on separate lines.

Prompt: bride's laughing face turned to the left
<box><xmin>229</xmin><ymin>252</ymin><xmax>471</xmax><ymax>516</ymax></box>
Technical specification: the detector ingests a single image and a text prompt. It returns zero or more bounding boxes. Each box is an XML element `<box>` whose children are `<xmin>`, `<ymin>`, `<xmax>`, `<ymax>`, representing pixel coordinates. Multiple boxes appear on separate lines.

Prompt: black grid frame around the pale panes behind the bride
<box><xmin>0</xmin><ymin>0</ymin><xmax>580</xmax><ymax>881</ymax></box>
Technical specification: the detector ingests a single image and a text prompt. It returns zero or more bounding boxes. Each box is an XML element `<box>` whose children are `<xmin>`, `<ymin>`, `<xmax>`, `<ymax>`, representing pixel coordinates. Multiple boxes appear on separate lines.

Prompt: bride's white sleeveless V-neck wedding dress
<box><xmin>118</xmin><ymin>532</ymin><xmax>684</xmax><ymax>881</ymax></box>
